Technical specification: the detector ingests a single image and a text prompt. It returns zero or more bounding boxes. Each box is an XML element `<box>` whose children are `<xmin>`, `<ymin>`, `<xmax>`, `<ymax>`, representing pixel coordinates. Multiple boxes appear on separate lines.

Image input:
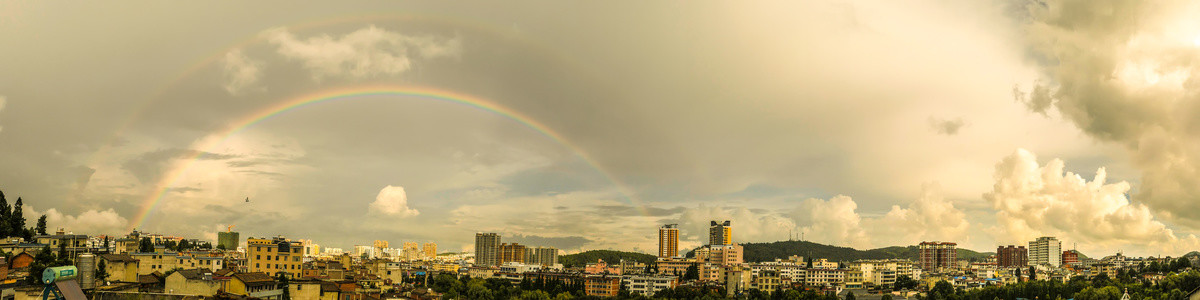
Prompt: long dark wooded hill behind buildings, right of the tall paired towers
<box><xmin>689</xmin><ymin>241</ymin><xmax>995</xmax><ymax>262</ymax></box>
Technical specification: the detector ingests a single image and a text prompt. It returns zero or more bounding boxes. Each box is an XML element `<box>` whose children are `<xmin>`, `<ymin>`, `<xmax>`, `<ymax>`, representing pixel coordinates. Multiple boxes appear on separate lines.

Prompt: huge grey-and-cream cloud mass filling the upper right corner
<box><xmin>1018</xmin><ymin>0</ymin><xmax>1200</xmax><ymax>225</ymax></box>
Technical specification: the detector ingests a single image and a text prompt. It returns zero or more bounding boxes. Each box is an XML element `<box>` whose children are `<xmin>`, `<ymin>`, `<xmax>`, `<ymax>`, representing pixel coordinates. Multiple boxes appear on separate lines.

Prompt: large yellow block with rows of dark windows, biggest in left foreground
<box><xmin>246</xmin><ymin>236</ymin><xmax>304</xmax><ymax>278</ymax></box>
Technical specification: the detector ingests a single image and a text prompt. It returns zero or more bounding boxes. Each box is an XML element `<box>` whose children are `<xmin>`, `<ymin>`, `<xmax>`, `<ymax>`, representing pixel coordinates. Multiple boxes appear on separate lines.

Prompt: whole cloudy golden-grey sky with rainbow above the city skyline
<box><xmin>0</xmin><ymin>0</ymin><xmax>1200</xmax><ymax>257</ymax></box>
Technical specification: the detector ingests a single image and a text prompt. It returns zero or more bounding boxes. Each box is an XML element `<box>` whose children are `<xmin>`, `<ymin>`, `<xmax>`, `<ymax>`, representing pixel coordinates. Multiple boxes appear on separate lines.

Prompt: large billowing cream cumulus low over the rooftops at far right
<box><xmin>984</xmin><ymin>149</ymin><xmax>1198</xmax><ymax>252</ymax></box>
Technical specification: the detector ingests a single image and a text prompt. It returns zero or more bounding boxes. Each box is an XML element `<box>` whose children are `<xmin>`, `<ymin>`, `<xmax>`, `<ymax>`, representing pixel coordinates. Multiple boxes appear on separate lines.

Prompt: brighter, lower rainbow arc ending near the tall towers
<box><xmin>130</xmin><ymin>85</ymin><xmax>649</xmax><ymax>230</ymax></box>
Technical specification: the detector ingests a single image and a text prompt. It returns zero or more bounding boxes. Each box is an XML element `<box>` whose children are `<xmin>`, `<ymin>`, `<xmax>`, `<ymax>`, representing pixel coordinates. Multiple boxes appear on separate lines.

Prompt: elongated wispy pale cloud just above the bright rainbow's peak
<box><xmin>264</xmin><ymin>25</ymin><xmax>462</xmax><ymax>80</ymax></box>
